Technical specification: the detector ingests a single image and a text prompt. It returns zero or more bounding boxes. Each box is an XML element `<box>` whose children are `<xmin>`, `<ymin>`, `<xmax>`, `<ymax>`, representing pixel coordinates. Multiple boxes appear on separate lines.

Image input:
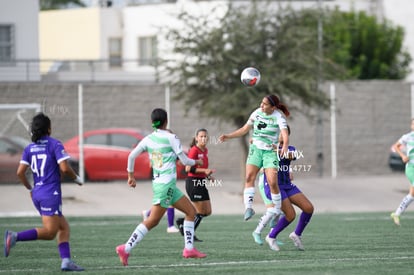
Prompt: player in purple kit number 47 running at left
<box><xmin>4</xmin><ymin>113</ymin><xmax>84</xmax><ymax>271</ymax></box>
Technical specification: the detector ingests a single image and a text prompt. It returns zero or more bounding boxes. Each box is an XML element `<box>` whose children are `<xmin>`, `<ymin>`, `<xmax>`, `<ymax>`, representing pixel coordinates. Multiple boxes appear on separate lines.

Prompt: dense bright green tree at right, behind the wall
<box><xmin>318</xmin><ymin>10</ymin><xmax>411</xmax><ymax>79</ymax></box>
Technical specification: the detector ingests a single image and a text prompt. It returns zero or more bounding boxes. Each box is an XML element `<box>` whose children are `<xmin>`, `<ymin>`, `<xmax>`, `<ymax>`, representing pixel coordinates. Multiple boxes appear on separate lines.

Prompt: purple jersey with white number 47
<box><xmin>20</xmin><ymin>136</ymin><xmax>70</xmax><ymax>196</ymax></box>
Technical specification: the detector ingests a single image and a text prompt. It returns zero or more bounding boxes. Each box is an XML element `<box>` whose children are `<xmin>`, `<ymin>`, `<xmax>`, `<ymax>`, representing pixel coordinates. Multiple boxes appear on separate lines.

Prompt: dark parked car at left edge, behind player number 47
<box><xmin>0</xmin><ymin>136</ymin><xmax>30</xmax><ymax>183</ymax></box>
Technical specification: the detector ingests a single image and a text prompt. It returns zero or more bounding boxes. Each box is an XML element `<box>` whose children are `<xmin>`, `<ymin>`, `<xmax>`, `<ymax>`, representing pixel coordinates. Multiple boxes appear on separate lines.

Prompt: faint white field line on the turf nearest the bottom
<box><xmin>0</xmin><ymin>254</ymin><xmax>414</xmax><ymax>274</ymax></box>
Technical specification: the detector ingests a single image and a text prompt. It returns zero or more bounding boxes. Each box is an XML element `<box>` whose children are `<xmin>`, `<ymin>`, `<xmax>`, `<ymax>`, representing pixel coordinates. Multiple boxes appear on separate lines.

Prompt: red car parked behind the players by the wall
<box><xmin>63</xmin><ymin>128</ymin><xmax>186</xmax><ymax>181</ymax></box>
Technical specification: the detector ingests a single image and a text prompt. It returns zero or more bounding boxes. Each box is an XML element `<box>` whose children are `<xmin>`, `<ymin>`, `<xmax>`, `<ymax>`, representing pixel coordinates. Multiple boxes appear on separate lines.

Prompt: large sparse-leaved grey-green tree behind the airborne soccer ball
<box><xmin>160</xmin><ymin>1</ymin><xmax>344</xmax><ymax>157</ymax></box>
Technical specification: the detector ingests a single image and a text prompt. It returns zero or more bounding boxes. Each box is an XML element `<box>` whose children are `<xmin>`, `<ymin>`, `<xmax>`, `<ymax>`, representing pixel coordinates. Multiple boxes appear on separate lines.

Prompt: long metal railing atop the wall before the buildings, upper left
<box><xmin>0</xmin><ymin>59</ymin><xmax>157</xmax><ymax>83</ymax></box>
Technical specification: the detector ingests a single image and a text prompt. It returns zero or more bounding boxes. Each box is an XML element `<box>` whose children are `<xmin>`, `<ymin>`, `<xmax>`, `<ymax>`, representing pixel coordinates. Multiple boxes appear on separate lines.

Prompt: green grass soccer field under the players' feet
<box><xmin>0</xmin><ymin>213</ymin><xmax>414</xmax><ymax>275</ymax></box>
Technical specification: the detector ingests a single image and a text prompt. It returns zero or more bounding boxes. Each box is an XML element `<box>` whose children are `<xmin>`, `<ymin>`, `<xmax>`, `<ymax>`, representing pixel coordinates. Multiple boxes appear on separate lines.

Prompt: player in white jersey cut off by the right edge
<box><xmin>391</xmin><ymin>118</ymin><xmax>414</xmax><ymax>225</ymax></box>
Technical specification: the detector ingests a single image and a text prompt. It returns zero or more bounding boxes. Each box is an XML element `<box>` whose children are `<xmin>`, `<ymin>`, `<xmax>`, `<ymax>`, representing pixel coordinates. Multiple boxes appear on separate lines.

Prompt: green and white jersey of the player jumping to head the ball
<box><xmin>247</xmin><ymin>108</ymin><xmax>287</xmax><ymax>150</ymax></box>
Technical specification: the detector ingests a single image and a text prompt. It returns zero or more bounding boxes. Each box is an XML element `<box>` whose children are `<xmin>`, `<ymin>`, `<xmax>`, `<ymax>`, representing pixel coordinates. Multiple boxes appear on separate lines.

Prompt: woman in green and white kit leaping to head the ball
<box><xmin>219</xmin><ymin>95</ymin><xmax>289</xmax><ymax>221</ymax></box>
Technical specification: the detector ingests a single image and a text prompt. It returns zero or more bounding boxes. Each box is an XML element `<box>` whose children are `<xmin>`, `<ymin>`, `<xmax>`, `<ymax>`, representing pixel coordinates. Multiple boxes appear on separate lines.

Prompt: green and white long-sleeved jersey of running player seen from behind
<box><xmin>127</xmin><ymin>129</ymin><xmax>195</xmax><ymax>184</ymax></box>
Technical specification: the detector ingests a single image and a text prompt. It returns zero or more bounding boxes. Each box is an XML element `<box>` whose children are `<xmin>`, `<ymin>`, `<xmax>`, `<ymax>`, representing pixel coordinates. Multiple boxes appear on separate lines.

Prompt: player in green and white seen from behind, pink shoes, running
<box><xmin>116</xmin><ymin>108</ymin><xmax>206</xmax><ymax>266</ymax></box>
